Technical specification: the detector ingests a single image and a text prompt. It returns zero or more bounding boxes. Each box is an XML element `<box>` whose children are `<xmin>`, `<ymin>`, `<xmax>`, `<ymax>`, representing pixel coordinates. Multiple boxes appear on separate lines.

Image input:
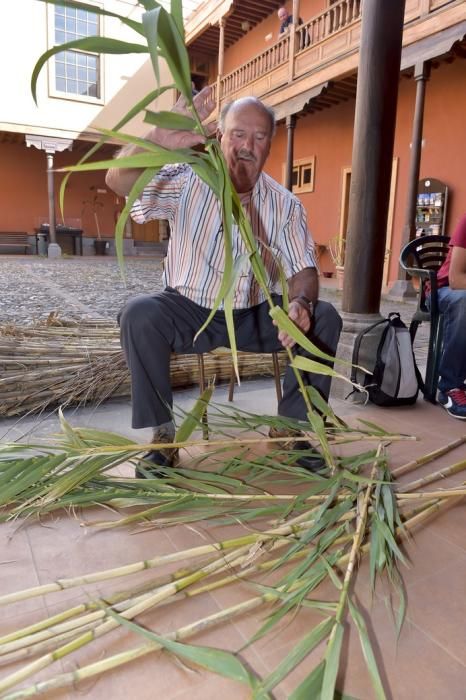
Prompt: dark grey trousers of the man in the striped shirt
<box><xmin>119</xmin><ymin>288</ymin><xmax>341</xmax><ymax>428</ymax></box>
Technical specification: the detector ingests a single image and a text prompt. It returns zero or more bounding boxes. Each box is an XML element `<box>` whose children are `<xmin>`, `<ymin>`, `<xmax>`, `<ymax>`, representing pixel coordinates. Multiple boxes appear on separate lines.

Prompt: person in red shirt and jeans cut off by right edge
<box><xmin>437</xmin><ymin>214</ymin><xmax>466</xmax><ymax>420</ymax></box>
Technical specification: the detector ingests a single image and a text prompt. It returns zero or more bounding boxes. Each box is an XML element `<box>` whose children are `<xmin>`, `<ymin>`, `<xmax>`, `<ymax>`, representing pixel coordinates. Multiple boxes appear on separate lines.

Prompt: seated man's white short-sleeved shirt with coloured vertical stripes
<box><xmin>131</xmin><ymin>164</ymin><xmax>317</xmax><ymax>309</ymax></box>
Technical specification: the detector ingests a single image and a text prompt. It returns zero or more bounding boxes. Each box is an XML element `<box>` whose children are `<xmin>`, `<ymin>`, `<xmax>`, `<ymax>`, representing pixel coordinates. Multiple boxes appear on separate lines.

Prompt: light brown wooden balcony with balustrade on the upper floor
<box><xmin>214</xmin><ymin>0</ymin><xmax>466</xmax><ymax>111</ymax></box>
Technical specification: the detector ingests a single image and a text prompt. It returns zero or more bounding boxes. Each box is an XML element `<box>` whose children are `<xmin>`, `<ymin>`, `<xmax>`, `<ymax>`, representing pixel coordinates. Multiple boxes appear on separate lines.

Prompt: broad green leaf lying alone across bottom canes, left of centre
<box><xmin>104</xmin><ymin>606</ymin><xmax>253</xmax><ymax>687</ymax></box>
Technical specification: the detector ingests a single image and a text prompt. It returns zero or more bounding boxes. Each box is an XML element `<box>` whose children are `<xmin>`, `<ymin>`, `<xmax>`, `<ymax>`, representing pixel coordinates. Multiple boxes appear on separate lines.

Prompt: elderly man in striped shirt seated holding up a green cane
<box><xmin>107</xmin><ymin>88</ymin><xmax>341</xmax><ymax>475</ymax></box>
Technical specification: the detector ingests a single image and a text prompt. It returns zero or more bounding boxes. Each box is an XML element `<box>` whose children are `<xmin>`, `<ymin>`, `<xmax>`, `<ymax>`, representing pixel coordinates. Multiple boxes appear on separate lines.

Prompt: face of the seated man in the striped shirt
<box><xmin>219</xmin><ymin>103</ymin><xmax>272</xmax><ymax>193</ymax></box>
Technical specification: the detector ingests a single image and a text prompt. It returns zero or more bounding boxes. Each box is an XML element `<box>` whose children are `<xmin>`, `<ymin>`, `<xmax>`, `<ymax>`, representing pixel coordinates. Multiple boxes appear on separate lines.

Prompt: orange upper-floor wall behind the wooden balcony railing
<box><xmin>224</xmin><ymin>0</ymin><xmax>328</xmax><ymax>74</ymax></box>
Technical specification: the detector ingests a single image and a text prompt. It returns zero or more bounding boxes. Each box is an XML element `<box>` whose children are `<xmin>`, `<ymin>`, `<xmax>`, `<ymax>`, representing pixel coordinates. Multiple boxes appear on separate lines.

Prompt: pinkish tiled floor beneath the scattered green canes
<box><xmin>0</xmin><ymin>380</ymin><xmax>466</xmax><ymax>700</ymax></box>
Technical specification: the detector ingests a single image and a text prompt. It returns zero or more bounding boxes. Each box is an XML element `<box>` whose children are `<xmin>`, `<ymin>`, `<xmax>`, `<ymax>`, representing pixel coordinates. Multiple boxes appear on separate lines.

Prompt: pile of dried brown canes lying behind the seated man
<box><xmin>0</xmin><ymin>314</ymin><xmax>286</xmax><ymax>416</ymax></box>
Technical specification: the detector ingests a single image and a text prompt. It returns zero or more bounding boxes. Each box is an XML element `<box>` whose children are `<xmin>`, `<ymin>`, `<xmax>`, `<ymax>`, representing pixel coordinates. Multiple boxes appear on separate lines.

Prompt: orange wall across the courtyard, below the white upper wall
<box><xmin>0</xmin><ymin>143</ymin><xmax>121</xmax><ymax>237</ymax></box>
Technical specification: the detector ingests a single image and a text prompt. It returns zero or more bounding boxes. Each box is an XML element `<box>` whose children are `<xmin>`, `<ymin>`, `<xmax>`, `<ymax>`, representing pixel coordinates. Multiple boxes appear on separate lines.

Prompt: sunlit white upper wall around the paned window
<box><xmin>0</xmin><ymin>0</ymin><xmax>147</xmax><ymax>138</ymax></box>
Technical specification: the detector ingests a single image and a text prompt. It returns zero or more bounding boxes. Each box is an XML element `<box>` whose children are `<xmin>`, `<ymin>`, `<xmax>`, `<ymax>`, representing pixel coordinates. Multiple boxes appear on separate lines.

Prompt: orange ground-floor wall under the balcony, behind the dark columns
<box><xmin>266</xmin><ymin>59</ymin><xmax>466</xmax><ymax>281</ymax></box>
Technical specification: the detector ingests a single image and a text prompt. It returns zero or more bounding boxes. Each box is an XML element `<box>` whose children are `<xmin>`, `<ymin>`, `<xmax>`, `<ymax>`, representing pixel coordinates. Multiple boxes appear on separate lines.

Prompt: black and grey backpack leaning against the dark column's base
<box><xmin>351</xmin><ymin>312</ymin><xmax>423</xmax><ymax>406</ymax></box>
